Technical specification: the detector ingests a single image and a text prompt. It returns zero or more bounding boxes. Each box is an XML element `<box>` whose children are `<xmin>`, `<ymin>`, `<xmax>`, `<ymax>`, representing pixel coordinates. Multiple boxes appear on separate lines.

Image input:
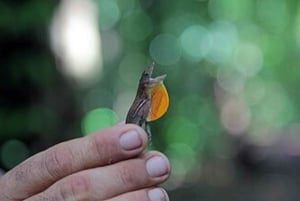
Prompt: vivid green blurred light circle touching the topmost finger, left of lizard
<box><xmin>82</xmin><ymin>108</ymin><xmax>118</xmax><ymax>135</ymax></box>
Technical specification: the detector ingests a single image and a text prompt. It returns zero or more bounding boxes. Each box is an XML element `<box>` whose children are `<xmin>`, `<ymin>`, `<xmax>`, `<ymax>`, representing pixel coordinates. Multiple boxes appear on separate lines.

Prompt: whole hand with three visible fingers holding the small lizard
<box><xmin>0</xmin><ymin>124</ymin><xmax>170</xmax><ymax>201</ymax></box>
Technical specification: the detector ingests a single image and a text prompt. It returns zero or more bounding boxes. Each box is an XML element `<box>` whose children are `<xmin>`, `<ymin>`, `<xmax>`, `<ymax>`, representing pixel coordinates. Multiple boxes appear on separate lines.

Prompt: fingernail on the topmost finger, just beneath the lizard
<box><xmin>120</xmin><ymin>130</ymin><xmax>143</xmax><ymax>150</ymax></box>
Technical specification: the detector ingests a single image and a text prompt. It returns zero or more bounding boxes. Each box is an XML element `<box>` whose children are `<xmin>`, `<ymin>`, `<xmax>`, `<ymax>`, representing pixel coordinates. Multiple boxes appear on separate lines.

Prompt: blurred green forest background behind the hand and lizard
<box><xmin>0</xmin><ymin>0</ymin><xmax>300</xmax><ymax>201</ymax></box>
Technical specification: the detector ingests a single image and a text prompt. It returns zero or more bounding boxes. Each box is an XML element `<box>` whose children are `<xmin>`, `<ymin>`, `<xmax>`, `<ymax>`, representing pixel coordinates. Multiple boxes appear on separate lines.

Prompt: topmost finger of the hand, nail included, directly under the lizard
<box><xmin>0</xmin><ymin>124</ymin><xmax>147</xmax><ymax>201</ymax></box>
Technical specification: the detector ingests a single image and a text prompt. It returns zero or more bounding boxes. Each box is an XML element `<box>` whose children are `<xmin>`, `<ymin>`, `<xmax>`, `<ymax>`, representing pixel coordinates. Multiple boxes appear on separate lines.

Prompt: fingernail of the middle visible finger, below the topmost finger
<box><xmin>146</xmin><ymin>156</ymin><xmax>169</xmax><ymax>177</ymax></box>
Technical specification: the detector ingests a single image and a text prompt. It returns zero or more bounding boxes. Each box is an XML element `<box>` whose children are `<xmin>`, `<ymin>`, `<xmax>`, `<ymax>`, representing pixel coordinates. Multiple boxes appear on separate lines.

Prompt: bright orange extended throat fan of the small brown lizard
<box><xmin>147</xmin><ymin>83</ymin><xmax>169</xmax><ymax>121</ymax></box>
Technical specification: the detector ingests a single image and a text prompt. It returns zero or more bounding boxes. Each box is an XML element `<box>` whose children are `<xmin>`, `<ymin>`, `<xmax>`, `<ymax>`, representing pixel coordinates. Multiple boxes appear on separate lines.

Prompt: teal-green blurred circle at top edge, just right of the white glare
<box><xmin>97</xmin><ymin>0</ymin><xmax>120</xmax><ymax>30</ymax></box>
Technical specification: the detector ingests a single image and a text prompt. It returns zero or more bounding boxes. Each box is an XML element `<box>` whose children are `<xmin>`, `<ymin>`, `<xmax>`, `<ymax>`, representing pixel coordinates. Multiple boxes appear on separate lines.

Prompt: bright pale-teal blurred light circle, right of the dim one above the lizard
<box><xmin>180</xmin><ymin>25</ymin><xmax>212</xmax><ymax>61</ymax></box>
